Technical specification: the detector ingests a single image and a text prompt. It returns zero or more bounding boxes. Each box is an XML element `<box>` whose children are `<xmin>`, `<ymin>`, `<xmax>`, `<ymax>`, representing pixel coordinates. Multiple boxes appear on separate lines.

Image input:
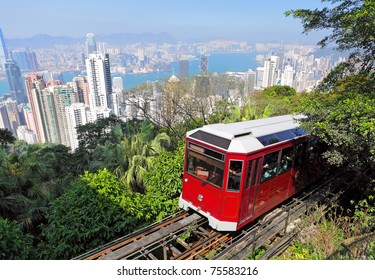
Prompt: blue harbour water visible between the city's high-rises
<box><xmin>0</xmin><ymin>52</ymin><xmax>261</xmax><ymax>96</ymax></box>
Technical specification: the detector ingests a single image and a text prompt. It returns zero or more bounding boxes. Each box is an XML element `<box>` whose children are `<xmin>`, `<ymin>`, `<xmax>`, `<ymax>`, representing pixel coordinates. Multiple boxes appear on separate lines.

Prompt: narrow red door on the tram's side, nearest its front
<box><xmin>240</xmin><ymin>158</ymin><xmax>261</xmax><ymax>222</ymax></box>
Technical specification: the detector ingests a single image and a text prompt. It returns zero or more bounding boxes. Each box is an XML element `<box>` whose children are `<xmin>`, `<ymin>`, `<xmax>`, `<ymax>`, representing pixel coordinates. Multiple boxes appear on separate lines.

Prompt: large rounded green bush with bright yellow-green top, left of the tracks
<box><xmin>38</xmin><ymin>169</ymin><xmax>143</xmax><ymax>259</ymax></box>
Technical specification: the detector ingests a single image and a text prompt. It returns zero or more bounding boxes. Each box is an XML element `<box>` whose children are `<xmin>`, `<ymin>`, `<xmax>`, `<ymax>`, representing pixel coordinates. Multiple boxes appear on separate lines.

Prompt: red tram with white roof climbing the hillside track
<box><xmin>179</xmin><ymin>115</ymin><xmax>315</xmax><ymax>231</ymax></box>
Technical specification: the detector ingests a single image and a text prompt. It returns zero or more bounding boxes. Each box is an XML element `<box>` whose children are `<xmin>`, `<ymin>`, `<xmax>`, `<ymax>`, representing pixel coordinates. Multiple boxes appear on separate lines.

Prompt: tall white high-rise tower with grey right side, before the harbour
<box><xmin>86</xmin><ymin>53</ymin><xmax>113</xmax><ymax>111</ymax></box>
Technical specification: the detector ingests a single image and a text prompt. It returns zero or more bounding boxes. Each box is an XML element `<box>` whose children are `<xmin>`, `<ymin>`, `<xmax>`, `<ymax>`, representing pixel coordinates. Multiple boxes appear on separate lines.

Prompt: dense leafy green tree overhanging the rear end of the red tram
<box><xmin>302</xmin><ymin>76</ymin><xmax>375</xmax><ymax>171</ymax></box>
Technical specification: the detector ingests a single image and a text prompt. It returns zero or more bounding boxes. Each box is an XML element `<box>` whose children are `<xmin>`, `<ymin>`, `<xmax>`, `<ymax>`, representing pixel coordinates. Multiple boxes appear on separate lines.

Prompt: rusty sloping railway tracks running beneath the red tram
<box><xmin>75</xmin><ymin>168</ymin><xmax>350</xmax><ymax>260</ymax></box>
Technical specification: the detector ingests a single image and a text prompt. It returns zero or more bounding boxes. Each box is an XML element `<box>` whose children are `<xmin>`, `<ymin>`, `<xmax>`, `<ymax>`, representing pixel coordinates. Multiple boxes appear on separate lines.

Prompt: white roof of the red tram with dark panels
<box><xmin>187</xmin><ymin>115</ymin><xmax>306</xmax><ymax>153</ymax></box>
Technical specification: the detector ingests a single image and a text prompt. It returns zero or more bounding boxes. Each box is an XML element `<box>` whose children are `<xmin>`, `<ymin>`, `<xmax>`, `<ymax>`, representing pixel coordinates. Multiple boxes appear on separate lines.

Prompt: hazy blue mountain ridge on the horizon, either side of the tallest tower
<box><xmin>5</xmin><ymin>32</ymin><xmax>177</xmax><ymax>49</ymax></box>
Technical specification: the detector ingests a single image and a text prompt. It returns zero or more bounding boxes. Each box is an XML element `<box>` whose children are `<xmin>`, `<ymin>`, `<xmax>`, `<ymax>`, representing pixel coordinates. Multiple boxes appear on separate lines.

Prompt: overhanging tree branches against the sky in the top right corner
<box><xmin>286</xmin><ymin>0</ymin><xmax>375</xmax><ymax>73</ymax></box>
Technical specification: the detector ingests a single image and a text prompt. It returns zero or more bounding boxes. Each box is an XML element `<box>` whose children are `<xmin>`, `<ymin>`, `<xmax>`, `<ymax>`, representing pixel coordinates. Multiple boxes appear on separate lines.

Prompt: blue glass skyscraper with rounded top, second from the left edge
<box><xmin>5</xmin><ymin>59</ymin><xmax>27</xmax><ymax>104</ymax></box>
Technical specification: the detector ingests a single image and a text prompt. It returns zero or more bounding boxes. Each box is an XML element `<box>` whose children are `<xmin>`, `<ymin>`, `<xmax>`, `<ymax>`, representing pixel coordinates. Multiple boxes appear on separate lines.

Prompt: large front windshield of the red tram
<box><xmin>186</xmin><ymin>150</ymin><xmax>224</xmax><ymax>188</ymax></box>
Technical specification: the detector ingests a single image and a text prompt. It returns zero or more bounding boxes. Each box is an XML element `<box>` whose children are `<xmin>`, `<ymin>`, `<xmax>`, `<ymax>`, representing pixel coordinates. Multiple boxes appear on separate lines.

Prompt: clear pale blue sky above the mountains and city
<box><xmin>0</xmin><ymin>0</ymin><xmax>332</xmax><ymax>43</ymax></box>
